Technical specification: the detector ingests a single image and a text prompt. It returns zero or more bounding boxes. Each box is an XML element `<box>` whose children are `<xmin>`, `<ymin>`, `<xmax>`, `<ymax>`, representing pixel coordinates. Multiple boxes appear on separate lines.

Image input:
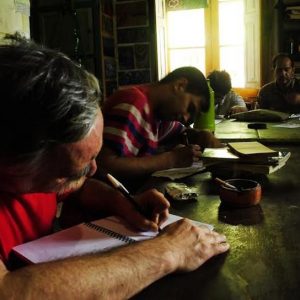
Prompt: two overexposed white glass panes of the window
<box><xmin>167</xmin><ymin>0</ymin><xmax>246</xmax><ymax>87</ymax></box>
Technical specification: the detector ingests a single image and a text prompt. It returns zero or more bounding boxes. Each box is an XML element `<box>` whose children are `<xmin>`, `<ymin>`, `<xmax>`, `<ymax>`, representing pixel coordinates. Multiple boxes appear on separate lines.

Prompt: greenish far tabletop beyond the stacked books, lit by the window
<box><xmin>215</xmin><ymin>119</ymin><xmax>300</xmax><ymax>144</ymax></box>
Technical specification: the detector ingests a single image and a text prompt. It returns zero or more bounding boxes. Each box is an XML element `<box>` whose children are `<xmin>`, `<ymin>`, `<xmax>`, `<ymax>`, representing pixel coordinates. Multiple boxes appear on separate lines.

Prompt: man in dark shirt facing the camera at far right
<box><xmin>258</xmin><ymin>53</ymin><xmax>300</xmax><ymax>113</ymax></box>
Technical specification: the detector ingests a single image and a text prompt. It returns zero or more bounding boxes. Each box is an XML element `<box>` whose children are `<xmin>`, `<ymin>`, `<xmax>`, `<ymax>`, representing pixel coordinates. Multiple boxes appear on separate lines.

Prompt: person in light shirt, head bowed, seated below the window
<box><xmin>207</xmin><ymin>70</ymin><xmax>247</xmax><ymax>116</ymax></box>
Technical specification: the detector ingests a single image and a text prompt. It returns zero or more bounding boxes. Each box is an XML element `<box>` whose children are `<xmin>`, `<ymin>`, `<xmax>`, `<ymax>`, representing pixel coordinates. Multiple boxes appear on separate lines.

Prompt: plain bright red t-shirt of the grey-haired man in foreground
<box><xmin>0</xmin><ymin>193</ymin><xmax>57</xmax><ymax>263</ymax></box>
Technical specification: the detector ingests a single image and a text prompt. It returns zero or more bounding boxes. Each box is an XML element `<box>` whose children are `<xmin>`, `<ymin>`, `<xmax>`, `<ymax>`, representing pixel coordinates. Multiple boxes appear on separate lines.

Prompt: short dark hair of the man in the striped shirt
<box><xmin>159</xmin><ymin>67</ymin><xmax>209</xmax><ymax>112</ymax></box>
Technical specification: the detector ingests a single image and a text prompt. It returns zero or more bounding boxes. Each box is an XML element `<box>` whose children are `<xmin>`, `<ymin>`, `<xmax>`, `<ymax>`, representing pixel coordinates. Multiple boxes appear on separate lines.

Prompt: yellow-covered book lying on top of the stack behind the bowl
<box><xmin>228</xmin><ymin>141</ymin><xmax>278</xmax><ymax>158</ymax></box>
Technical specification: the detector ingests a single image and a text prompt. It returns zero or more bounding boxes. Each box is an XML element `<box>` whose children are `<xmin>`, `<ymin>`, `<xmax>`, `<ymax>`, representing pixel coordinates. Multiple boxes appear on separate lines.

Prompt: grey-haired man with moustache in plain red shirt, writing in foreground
<box><xmin>0</xmin><ymin>36</ymin><xmax>229</xmax><ymax>299</ymax></box>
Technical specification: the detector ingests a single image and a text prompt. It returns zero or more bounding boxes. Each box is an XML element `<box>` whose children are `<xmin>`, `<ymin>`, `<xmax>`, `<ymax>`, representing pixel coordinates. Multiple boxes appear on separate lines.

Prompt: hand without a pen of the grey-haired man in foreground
<box><xmin>159</xmin><ymin>219</ymin><xmax>229</xmax><ymax>272</ymax></box>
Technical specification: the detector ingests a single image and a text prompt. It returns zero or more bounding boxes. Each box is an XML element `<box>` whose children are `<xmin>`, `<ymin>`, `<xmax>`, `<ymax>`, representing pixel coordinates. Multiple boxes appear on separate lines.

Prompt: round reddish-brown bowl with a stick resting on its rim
<box><xmin>220</xmin><ymin>179</ymin><xmax>261</xmax><ymax>207</ymax></box>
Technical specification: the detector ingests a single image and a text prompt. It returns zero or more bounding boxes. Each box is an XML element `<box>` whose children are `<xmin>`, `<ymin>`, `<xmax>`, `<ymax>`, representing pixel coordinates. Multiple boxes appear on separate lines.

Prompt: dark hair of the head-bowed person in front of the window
<box><xmin>207</xmin><ymin>70</ymin><xmax>232</xmax><ymax>96</ymax></box>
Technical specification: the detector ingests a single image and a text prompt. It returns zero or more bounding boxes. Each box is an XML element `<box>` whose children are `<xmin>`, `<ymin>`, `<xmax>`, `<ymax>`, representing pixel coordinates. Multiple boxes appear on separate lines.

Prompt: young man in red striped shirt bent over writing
<box><xmin>99</xmin><ymin>67</ymin><xmax>222</xmax><ymax>188</ymax></box>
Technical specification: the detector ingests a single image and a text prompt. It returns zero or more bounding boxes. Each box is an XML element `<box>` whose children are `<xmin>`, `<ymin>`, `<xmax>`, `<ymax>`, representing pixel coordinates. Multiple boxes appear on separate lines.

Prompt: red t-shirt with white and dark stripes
<box><xmin>102</xmin><ymin>85</ymin><xmax>184</xmax><ymax>157</ymax></box>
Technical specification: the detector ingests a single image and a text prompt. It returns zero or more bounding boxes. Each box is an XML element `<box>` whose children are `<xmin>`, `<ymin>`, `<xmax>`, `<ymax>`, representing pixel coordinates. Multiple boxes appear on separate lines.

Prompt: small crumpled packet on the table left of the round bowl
<box><xmin>166</xmin><ymin>182</ymin><xmax>198</xmax><ymax>201</ymax></box>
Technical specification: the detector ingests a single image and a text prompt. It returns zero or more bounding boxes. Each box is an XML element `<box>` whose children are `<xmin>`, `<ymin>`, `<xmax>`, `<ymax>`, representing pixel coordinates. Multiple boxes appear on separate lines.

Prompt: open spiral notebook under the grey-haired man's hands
<box><xmin>13</xmin><ymin>214</ymin><xmax>213</xmax><ymax>264</ymax></box>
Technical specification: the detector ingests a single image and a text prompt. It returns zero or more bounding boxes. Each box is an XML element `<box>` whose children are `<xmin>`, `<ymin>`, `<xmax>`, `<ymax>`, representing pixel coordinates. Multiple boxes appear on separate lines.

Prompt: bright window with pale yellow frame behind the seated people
<box><xmin>158</xmin><ymin>0</ymin><xmax>260</xmax><ymax>87</ymax></box>
